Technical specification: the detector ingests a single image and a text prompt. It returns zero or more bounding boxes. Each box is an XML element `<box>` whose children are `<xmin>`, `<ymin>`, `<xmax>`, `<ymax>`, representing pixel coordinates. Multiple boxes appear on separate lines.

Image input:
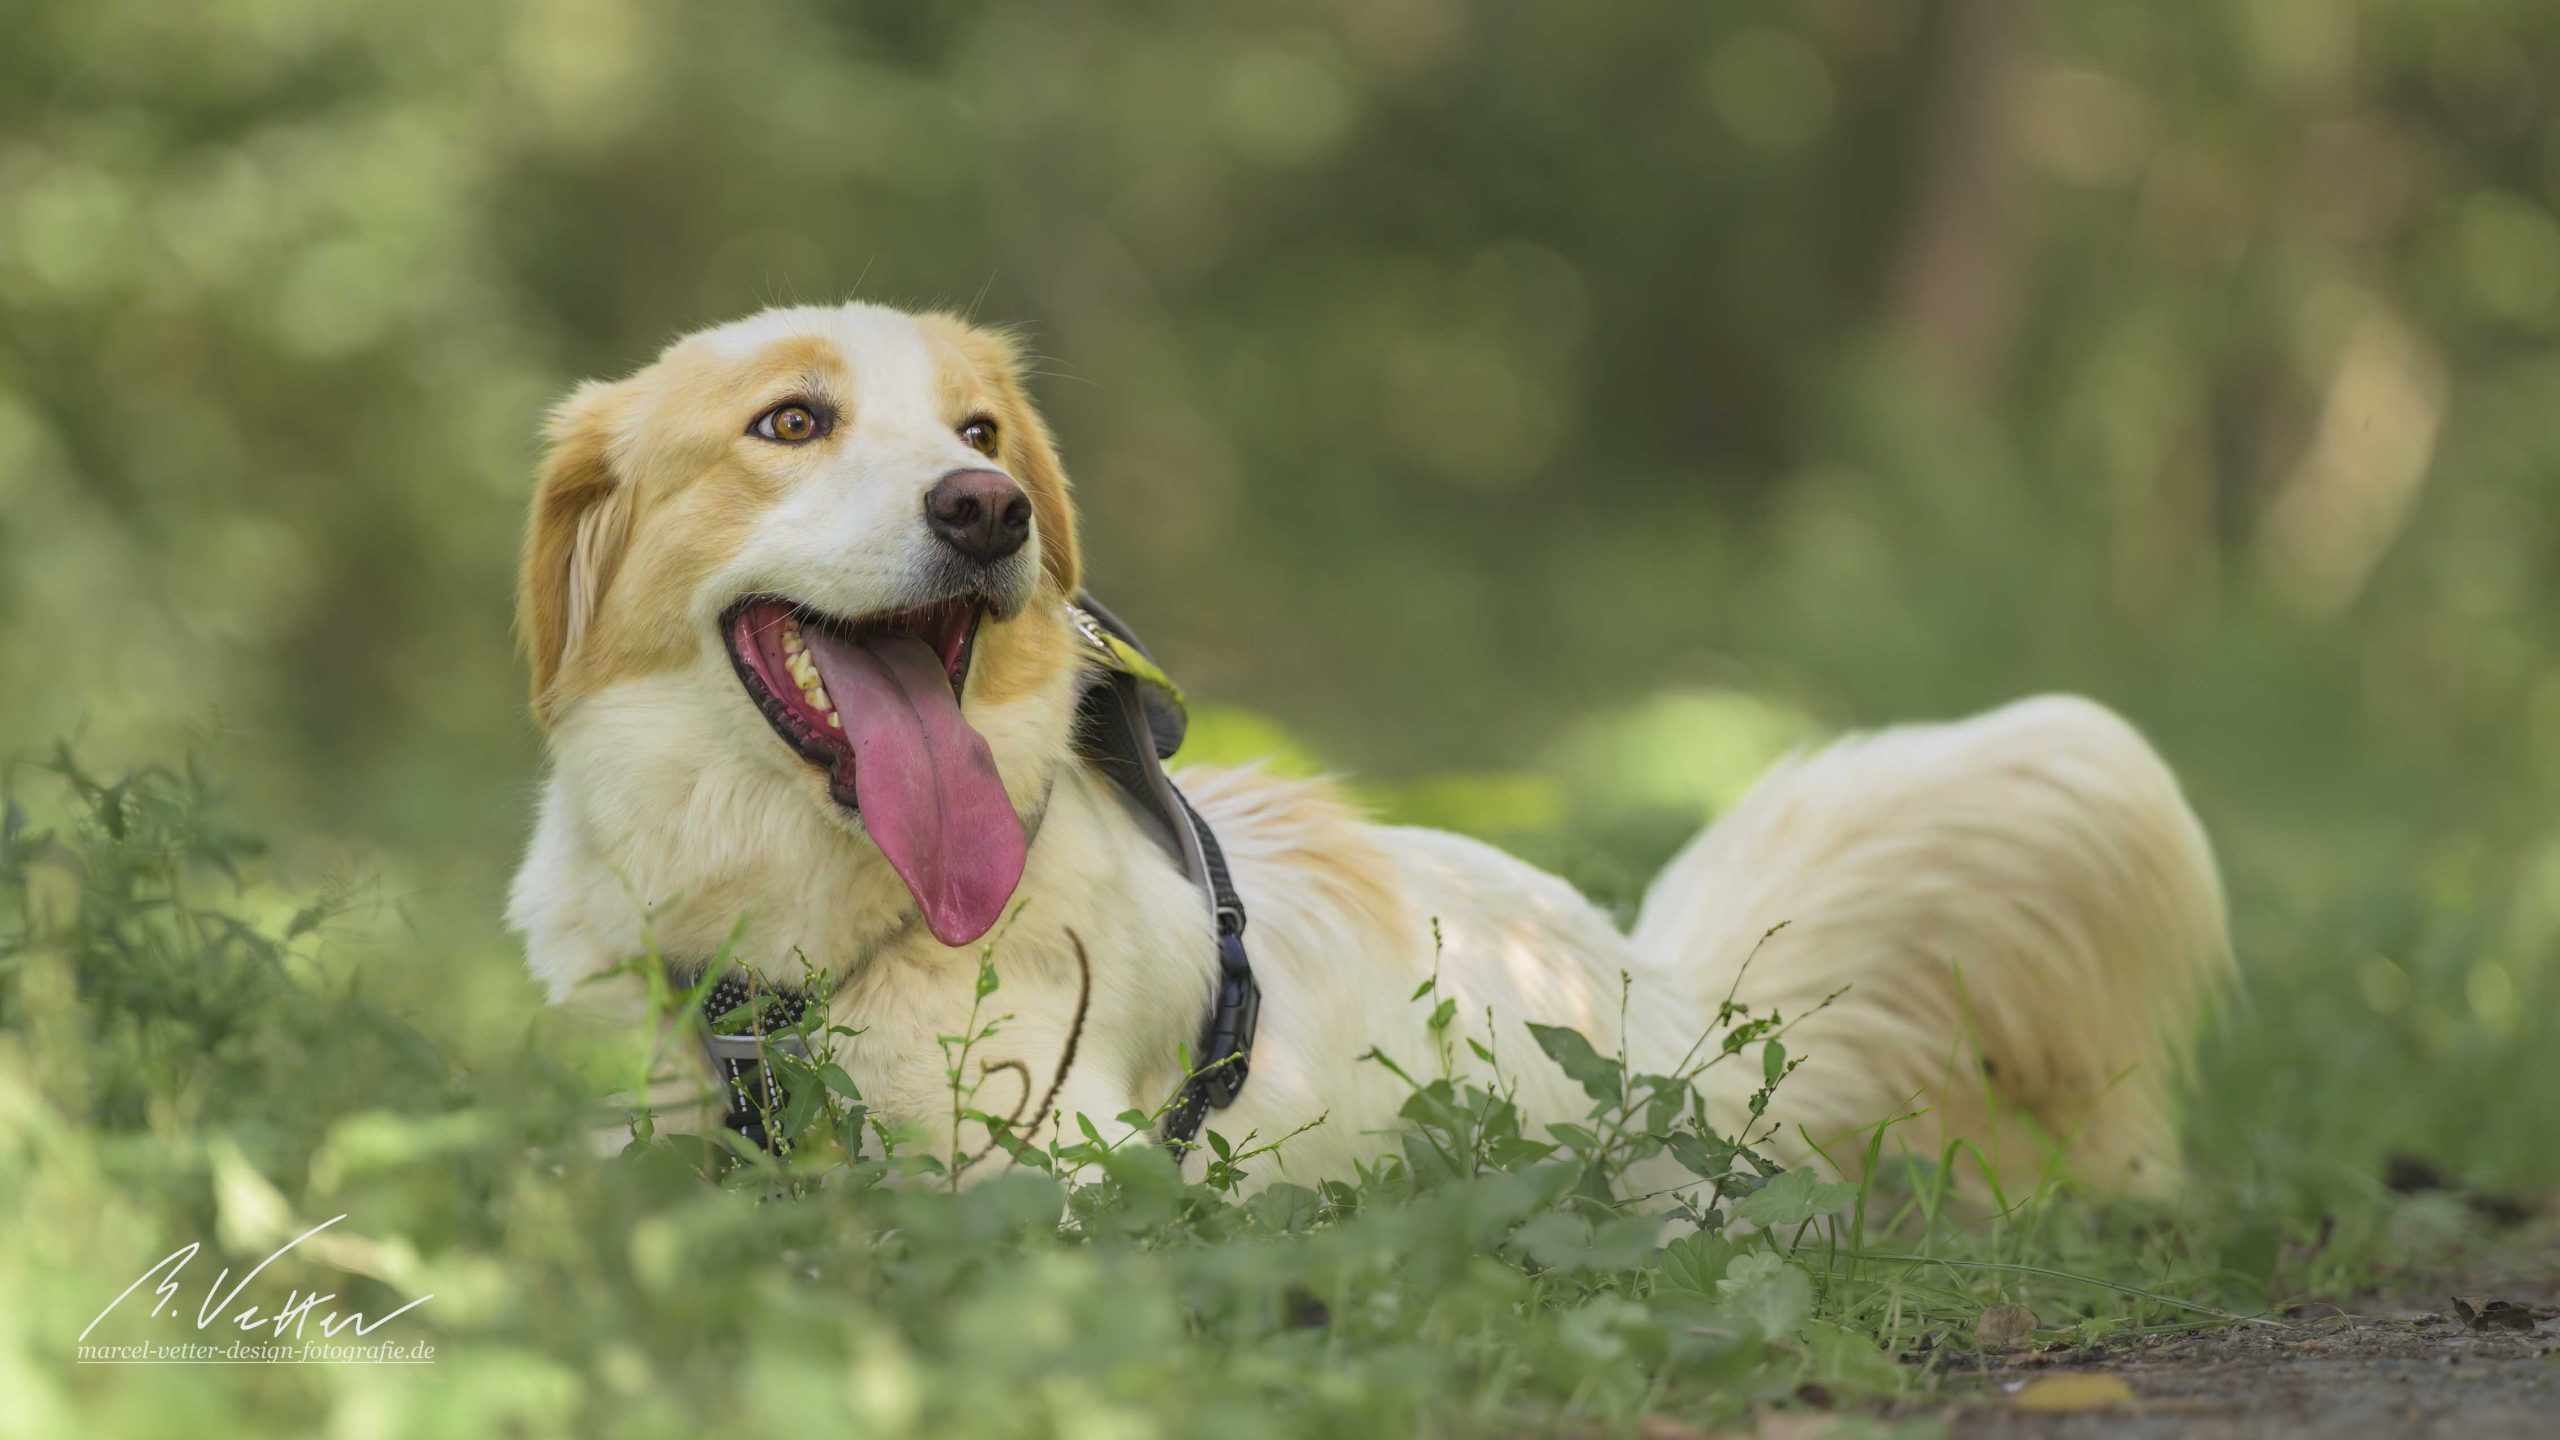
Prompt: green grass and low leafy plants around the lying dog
<box><xmin>0</xmin><ymin>753</ymin><xmax>2550</xmax><ymax>1440</ymax></box>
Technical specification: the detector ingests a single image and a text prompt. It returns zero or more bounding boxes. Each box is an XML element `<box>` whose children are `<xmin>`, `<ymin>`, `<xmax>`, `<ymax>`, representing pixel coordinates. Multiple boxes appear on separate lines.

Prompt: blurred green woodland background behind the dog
<box><xmin>0</xmin><ymin>0</ymin><xmax>2560</xmax><ymax>1184</ymax></box>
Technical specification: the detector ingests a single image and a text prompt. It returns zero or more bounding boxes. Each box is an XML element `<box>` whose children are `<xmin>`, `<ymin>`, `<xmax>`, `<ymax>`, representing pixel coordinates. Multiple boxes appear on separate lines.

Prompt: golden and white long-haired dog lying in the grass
<box><xmin>509</xmin><ymin>305</ymin><xmax>2230</xmax><ymax>1191</ymax></box>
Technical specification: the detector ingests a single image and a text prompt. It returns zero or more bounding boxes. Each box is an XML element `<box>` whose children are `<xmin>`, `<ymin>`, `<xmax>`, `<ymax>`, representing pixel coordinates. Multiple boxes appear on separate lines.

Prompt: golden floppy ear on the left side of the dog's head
<box><xmin>515</xmin><ymin>382</ymin><xmax>632</xmax><ymax>725</ymax></box>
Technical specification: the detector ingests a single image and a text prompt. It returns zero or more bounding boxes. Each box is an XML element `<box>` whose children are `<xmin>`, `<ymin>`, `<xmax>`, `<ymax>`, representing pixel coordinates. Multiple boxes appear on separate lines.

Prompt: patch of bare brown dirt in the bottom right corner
<box><xmin>1946</xmin><ymin>1248</ymin><xmax>2560</xmax><ymax>1440</ymax></box>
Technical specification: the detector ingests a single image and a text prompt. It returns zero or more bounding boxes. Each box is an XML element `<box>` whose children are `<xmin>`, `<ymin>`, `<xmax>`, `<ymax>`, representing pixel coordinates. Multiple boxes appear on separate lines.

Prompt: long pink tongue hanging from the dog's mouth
<box><xmin>809</xmin><ymin>630</ymin><xmax>1024</xmax><ymax>945</ymax></box>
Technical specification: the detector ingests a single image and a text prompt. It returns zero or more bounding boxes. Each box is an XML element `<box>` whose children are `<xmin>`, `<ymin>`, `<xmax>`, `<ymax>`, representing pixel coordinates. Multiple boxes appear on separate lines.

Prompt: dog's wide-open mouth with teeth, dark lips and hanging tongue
<box><xmin>722</xmin><ymin>597</ymin><xmax>1024</xmax><ymax>945</ymax></box>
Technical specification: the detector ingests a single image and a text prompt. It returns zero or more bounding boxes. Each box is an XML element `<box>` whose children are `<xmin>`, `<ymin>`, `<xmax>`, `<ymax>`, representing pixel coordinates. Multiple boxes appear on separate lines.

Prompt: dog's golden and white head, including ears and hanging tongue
<box><xmin>517</xmin><ymin>305</ymin><xmax>1078</xmax><ymax>945</ymax></box>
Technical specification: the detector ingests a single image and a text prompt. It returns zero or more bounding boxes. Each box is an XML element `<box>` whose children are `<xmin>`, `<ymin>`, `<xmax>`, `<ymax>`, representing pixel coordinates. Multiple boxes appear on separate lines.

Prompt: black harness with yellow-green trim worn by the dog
<box><xmin>696</xmin><ymin>594</ymin><xmax>1262</xmax><ymax>1163</ymax></box>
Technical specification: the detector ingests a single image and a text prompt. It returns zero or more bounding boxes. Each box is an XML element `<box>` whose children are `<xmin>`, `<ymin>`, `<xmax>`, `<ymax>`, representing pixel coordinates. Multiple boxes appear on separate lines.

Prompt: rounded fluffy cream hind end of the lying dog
<box><xmin>1633</xmin><ymin>697</ymin><xmax>2232</xmax><ymax>1197</ymax></box>
